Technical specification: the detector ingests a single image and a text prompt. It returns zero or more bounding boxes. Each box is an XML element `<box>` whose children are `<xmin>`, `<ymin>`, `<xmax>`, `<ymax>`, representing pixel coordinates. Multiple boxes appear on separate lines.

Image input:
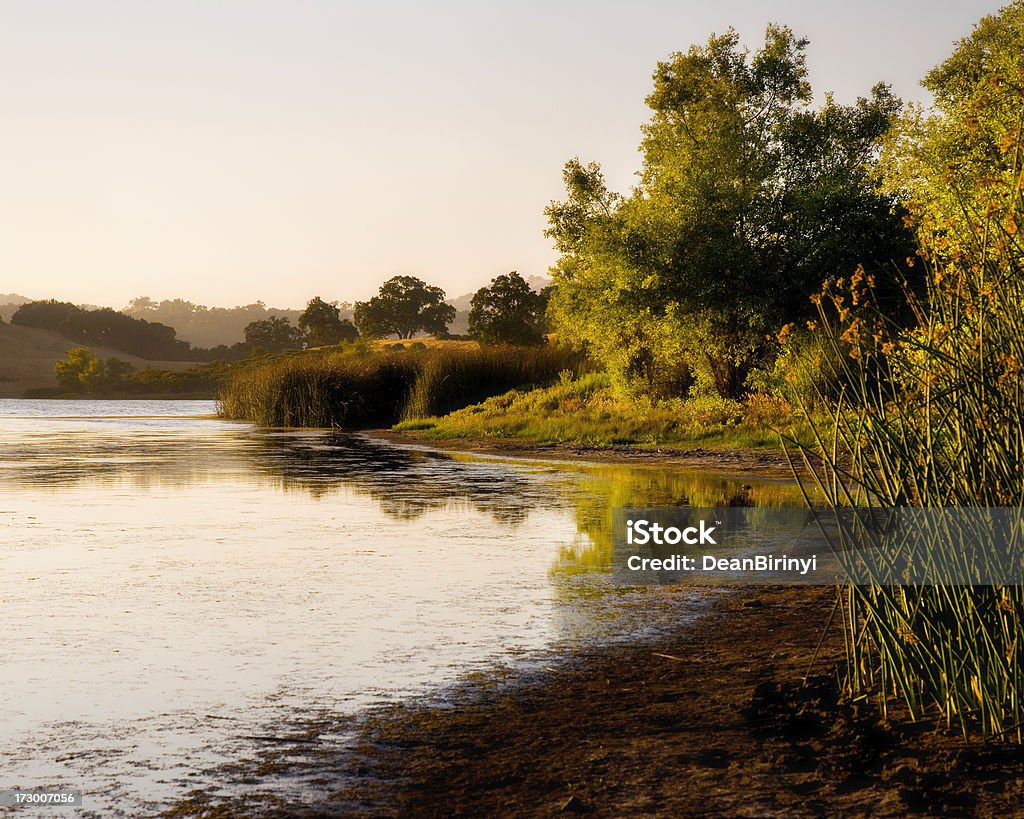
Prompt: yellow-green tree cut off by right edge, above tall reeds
<box><xmin>883</xmin><ymin>0</ymin><xmax>1024</xmax><ymax>264</ymax></box>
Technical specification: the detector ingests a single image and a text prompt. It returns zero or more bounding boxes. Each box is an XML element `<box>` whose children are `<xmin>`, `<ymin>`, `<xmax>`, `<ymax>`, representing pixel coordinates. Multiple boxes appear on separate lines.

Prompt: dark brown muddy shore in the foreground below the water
<box><xmin>161</xmin><ymin>588</ymin><xmax>1024</xmax><ymax>817</ymax></box>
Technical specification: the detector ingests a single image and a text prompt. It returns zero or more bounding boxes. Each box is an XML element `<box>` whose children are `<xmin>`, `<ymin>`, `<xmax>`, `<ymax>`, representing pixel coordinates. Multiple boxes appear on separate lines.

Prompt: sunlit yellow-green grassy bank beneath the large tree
<box><xmin>396</xmin><ymin>373</ymin><xmax>811</xmax><ymax>447</ymax></box>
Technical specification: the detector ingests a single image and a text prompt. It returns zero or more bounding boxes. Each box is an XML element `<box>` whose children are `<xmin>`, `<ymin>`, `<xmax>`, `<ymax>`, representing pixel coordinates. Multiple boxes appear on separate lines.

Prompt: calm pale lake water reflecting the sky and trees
<box><xmin>0</xmin><ymin>400</ymin><xmax>798</xmax><ymax>815</ymax></box>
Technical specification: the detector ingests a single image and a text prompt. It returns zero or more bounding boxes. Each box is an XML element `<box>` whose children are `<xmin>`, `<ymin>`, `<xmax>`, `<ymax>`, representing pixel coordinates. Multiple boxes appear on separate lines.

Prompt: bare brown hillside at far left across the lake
<box><xmin>0</xmin><ymin>324</ymin><xmax>195</xmax><ymax>398</ymax></box>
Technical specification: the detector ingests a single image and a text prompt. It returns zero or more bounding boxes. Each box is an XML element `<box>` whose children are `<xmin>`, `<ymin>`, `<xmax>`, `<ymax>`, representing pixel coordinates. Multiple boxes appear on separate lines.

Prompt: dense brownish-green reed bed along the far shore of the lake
<box><xmin>219</xmin><ymin>347</ymin><xmax>580</xmax><ymax>429</ymax></box>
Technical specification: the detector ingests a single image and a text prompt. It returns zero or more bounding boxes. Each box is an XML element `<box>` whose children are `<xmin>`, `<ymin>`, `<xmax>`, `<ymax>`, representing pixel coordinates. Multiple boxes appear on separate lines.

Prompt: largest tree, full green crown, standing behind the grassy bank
<box><xmin>546</xmin><ymin>26</ymin><xmax>912</xmax><ymax>395</ymax></box>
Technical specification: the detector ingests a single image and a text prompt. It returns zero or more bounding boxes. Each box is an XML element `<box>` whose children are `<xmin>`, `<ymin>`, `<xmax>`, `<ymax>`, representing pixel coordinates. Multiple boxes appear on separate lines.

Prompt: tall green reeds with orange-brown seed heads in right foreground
<box><xmin>798</xmin><ymin>151</ymin><xmax>1024</xmax><ymax>741</ymax></box>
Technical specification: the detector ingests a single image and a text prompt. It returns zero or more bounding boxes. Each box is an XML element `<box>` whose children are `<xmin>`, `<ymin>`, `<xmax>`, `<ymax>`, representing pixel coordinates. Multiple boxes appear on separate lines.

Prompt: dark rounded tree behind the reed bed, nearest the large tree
<box><xmin>469</xmin><ymin>270</ymin><xmax>546</xmax><ymax>344</ymax></box>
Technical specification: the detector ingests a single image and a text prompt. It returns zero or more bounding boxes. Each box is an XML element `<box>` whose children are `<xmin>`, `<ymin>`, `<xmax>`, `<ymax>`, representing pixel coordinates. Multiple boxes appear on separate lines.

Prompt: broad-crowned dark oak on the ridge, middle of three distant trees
<box><xmin>355</xmin><ymin>275</ymin><xmax>455</xmax><ymax>339</ymax></box>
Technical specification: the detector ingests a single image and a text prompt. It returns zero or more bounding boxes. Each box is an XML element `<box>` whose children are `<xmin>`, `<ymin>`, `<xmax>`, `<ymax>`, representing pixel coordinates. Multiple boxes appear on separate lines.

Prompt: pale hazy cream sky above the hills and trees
<box><xmin>0</xmin><ymin>0</ymin><xmax>1001</xmax><ymax>307</ymax></box>
